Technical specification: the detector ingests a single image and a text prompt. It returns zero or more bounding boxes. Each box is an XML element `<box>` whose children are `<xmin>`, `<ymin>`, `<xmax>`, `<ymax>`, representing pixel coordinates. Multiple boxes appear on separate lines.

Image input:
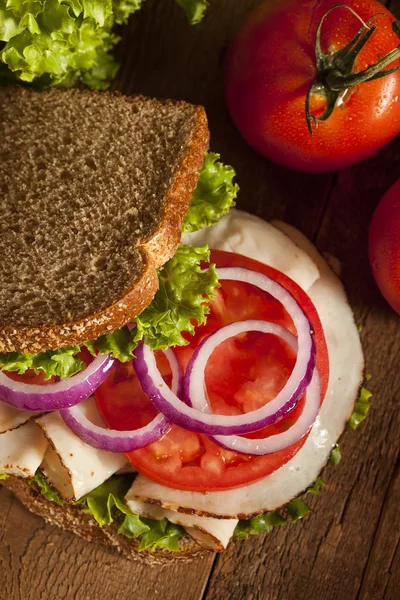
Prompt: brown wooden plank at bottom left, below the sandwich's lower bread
<box><xmin>0</xmin><ymin>488</ymin><xmax>214</xmax><ymax>600</ymax></box>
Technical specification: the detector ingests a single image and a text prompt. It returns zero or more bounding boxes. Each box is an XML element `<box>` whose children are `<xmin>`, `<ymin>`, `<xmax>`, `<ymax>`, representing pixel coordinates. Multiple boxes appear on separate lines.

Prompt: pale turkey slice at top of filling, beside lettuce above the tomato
<box><xmin>182</xmin><ymin>208</ymin><xmax>319</xmax><ymax>291</ymax></box>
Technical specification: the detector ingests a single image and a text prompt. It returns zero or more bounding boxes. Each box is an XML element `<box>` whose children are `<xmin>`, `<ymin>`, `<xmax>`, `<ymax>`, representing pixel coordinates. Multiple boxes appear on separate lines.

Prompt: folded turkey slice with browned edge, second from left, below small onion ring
<box><xmin>37</xmin><ymin>398</ymin><xmax>126</xmax><ymax>501</ymax></box>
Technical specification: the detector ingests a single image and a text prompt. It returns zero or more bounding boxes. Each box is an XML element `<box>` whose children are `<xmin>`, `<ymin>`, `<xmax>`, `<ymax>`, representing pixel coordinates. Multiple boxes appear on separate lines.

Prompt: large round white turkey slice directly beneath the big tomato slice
<box><xmin>130</xmin><ymin>218</ymin><xmax>364</xmax><ymax>518</ymax></box>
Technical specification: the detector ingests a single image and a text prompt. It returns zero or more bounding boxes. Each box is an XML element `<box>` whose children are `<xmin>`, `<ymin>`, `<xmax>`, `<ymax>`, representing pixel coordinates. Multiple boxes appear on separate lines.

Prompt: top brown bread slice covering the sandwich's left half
<box><xmin>0</xmin><ymin>86</ymin><xmax>209</xmax><ymax>353</ymax></box>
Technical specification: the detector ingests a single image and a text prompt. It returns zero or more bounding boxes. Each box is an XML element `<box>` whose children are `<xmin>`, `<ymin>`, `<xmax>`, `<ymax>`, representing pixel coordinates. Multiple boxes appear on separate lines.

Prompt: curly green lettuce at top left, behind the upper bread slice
<box><xmin>0</xmin><ymin>0</ymin><xmax>207</xmax><ymax>89</ymax></box>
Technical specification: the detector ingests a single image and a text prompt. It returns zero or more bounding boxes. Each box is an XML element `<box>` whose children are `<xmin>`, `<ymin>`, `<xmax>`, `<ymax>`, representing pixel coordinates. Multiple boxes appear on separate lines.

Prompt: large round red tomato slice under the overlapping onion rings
<box><xmin>95</xmin><ymin>251</ymin><xmax>329</xmax><ymax>491</ymax></box>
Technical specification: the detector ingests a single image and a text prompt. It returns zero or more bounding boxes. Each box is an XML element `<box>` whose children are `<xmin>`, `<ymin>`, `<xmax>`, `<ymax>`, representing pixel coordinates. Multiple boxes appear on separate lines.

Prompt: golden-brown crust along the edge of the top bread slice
<box><xmin>0</xmin><ymin>90</ymin><xmax>209</xmax><ymax>354</ymax></box>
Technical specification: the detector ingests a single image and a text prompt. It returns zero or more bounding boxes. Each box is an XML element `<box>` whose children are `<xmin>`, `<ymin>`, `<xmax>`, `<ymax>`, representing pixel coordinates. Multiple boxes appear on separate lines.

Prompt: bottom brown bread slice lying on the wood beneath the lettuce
<box><xmin>0</xmin><ymin>477</ymin><xmax>211</xmax><ymax>565</ymax></box>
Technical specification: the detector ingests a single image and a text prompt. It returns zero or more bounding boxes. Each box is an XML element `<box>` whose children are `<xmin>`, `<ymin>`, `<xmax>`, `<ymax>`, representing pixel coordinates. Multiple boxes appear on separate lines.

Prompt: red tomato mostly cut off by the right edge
<box><xmin>369</xmin><ymin>179</ymin><xmax>400</xmax><ymax>313</ymax></box>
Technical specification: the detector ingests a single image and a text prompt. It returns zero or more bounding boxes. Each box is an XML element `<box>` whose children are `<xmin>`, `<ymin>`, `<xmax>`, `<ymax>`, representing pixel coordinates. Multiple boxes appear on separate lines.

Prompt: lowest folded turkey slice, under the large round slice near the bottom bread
<box><xmin>125</xmin><ymin>490</ymin><xmax>238</xmax><ymax>552</ymax></box>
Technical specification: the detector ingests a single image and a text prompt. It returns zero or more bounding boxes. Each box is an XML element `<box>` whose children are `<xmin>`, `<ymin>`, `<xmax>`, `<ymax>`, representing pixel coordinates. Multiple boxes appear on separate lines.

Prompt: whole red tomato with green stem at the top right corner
<box><xmin>226</xmin><ymin>0</ymin><xmax>400</xmax><ymax>172</ymax></box>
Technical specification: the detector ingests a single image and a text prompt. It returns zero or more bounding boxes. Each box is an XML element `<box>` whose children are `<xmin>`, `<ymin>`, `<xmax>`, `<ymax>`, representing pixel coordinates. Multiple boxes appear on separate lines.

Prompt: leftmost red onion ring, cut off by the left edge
<box><xmin>0</xmin><ymin>354</ymin><xmax>115</xmax><ymax>412</ymax></box>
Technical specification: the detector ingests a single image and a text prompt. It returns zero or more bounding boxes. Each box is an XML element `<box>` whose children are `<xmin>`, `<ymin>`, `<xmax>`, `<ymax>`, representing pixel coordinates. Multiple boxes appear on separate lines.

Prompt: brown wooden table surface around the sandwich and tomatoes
<box><xmin>0</xmin><ymin>0</ymin><xmax>400</xmax><ymax>600</ymax></box>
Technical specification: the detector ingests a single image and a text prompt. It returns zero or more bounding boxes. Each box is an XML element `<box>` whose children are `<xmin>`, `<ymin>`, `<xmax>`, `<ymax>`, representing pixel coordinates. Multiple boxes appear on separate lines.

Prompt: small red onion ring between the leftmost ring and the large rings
<box><xmin>60</xmin><ymin>349</ymin><xmax>183</xmax><ymax>453</ymax></box>
